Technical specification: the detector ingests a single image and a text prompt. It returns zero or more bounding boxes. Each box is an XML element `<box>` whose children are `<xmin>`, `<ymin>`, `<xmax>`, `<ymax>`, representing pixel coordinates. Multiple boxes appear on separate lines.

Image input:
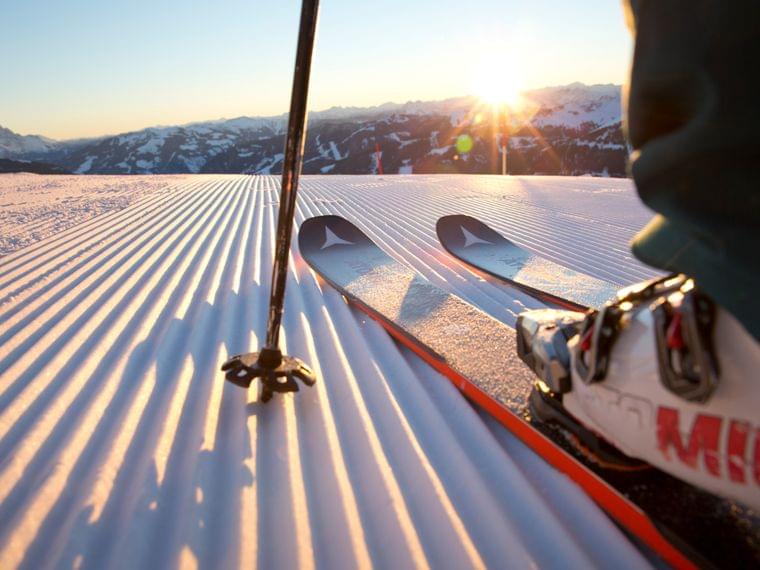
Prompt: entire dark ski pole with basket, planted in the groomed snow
<box><xmin>222</xmin><ymin>0</ymin><xmax>319</xmax><ymax>402</ymax></box>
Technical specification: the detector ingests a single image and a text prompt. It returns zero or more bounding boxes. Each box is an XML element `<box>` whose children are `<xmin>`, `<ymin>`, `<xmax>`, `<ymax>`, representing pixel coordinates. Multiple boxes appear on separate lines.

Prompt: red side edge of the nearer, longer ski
<box><xmin>336</xmin><ymin>288</ymin><xmax>697</xmax><ymax>569</ymax></box>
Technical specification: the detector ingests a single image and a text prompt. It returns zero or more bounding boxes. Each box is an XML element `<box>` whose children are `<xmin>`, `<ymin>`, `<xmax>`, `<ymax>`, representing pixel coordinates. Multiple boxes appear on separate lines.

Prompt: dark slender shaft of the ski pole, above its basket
<box><xmin>266</xmin><ymin>0</ymin><xmax>319</xmax><ymax>348</ymax></box>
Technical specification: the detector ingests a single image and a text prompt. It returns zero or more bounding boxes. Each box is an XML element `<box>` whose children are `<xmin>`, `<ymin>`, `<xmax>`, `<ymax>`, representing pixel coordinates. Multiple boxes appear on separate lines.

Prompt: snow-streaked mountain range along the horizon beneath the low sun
<box><xmin>2</xmin><ymin>83</ymin><xmax>628</xmax><ymax>176</ymax></box>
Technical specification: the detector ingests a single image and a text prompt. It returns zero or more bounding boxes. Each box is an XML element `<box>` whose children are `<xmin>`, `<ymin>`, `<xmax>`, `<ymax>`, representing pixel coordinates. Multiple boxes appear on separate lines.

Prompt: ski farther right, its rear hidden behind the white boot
<box><xmin>436</xmin><ymin>215</ymin><xmax>619</xmax><ymax>311</ymax></box>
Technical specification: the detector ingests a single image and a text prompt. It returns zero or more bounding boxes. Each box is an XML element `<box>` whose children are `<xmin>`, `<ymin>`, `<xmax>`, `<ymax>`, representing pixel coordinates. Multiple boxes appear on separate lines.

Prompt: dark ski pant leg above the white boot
<box><xmin>625</xmin><ymin>0</ymin><xmax>760</xmax><ymax>339</ymax></box>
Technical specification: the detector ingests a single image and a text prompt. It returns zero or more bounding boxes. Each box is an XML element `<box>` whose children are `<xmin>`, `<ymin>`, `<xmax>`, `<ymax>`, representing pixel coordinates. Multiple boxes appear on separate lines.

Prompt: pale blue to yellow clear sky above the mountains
<box><xmin>0</xmin><ymin>0</ymin><xmax>631</xmax><ymax>139</ymax></box>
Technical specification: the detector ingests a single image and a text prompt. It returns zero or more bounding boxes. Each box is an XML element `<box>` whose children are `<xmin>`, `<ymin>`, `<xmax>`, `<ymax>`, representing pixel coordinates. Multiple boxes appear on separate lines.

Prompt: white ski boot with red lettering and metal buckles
<box><xmin>517</xmin><ymin>276</ymin><xmax>760</xmax><ymax>510</ymax></box>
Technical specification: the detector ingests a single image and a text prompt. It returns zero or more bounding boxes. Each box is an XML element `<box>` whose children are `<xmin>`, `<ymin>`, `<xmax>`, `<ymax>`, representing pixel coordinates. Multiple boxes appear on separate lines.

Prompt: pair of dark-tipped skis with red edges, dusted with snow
<box><xmin>298</xmin><ymin>216</ymin><xmax>759</xmax><ymax>567</ymax></box>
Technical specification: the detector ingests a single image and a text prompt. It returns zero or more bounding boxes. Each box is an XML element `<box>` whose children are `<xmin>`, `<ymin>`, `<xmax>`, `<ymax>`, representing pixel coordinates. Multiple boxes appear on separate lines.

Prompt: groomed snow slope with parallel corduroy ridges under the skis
<box><xmin>0</xmin><ymin>175</ymin><xmax>653</xmax><ymax>568</ymax></box>
